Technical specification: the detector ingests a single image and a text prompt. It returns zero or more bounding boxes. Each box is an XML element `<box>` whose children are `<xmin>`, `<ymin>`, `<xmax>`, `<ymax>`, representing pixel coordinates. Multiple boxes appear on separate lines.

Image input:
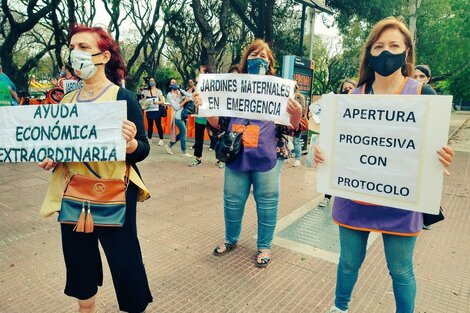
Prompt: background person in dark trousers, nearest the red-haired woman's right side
<box><xmin>145</xmin><ymin>77</ymin><xmax>165</xmax><ymax>146</ymax></box>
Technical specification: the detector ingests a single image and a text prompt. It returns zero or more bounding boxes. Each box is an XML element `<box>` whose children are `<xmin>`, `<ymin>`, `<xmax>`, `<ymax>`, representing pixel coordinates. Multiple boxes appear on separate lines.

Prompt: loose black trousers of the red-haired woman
<box><xmin>61</xmin><ymin>183</ymin><xmax>152</xmax><ymax>313</ymax></box>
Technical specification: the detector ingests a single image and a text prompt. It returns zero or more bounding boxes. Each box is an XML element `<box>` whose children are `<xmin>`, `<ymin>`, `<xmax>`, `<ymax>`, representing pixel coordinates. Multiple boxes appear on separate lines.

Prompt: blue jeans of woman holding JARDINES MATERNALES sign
<box><xmin>224</xmin><ymin>160</ymin><xmax>283</xmax><ymax>250</ymax></box>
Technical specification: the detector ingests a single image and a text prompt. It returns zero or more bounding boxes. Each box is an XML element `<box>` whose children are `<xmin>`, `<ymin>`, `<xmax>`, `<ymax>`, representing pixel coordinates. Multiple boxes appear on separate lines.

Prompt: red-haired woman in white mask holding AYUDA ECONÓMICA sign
<box><xmin>39</xmin><ymin>26</ymin><xmax>152</xmax><ymax>313</ymax></box>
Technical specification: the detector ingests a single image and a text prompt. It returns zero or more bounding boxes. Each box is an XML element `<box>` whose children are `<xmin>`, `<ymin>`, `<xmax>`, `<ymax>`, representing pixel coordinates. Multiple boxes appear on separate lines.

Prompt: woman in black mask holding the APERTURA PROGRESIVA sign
<box><xmin>315</xmin><ymin>18</ymin><xmax>454</xmax><ymax>313</ymax></box>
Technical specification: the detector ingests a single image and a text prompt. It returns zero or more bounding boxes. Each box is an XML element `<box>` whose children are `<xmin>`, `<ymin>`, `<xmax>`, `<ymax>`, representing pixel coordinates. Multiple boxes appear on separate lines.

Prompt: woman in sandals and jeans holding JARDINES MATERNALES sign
<box><xmin>195</xmin><ymin>39</ymin><xmax>302</xmax><ymax>267</ymax></box>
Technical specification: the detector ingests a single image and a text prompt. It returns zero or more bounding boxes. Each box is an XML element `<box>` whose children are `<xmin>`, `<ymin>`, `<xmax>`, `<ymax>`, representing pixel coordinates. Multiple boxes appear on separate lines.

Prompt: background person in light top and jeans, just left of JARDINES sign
<box><xmin>164</xmin><ymin>79</ymin><xmax>193</xmax><ymax>158</ymax></box>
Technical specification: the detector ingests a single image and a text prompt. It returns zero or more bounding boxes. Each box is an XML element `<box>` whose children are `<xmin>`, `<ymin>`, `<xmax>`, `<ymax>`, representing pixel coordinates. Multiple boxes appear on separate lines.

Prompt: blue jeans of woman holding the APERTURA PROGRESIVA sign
<box><xmin>335</xmin><ymin>226</ymin><xmax>416</xmax><ymax>313</ymax></box>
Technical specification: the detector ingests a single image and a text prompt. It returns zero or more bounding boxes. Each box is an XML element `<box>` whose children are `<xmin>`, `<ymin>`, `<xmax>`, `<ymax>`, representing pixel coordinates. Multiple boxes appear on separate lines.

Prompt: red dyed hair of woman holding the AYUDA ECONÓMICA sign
<box><xmin>69</xmin><ymin>25</ymin><xmax>127</xmax><ymax>86</ymax></box>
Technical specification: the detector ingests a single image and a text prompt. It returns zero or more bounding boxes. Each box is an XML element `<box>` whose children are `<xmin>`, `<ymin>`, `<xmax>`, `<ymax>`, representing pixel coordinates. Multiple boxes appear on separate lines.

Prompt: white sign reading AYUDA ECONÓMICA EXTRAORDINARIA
<box><xmin>0</xmin><ymin>101</ymin><xmax>127</xmax><ymax>162</ymax></box>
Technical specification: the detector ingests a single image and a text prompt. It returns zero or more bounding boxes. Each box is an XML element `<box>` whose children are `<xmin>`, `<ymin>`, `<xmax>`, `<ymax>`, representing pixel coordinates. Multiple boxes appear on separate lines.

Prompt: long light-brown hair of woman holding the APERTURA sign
<box><xmin>358</xmin><ymin>17</ymin><xmax>415</xmax><ymax>86</ymax></box>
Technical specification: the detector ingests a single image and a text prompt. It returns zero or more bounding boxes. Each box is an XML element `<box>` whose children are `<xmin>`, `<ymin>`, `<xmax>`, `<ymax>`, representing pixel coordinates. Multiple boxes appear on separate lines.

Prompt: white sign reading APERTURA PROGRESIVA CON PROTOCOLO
<box><xmin>317</xmin><ymin>94</ymin><xmax>452</xmax><ymax>214</ymax></box>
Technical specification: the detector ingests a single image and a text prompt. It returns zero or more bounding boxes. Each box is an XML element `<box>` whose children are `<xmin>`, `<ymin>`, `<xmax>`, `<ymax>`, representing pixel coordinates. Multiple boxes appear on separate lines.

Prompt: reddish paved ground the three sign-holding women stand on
<box><xmin>0</xmin><ymin>114</ymin><xmax>470</xmax><ymax>313</ymax></box>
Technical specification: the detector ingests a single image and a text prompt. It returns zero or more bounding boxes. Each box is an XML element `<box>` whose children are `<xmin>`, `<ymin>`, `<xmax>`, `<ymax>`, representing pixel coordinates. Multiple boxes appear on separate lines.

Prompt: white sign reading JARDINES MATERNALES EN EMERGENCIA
<box><xmin>197</xmin><ymin>74</ymin><xmax>295</xmax><ymax>125</ymax></box>
